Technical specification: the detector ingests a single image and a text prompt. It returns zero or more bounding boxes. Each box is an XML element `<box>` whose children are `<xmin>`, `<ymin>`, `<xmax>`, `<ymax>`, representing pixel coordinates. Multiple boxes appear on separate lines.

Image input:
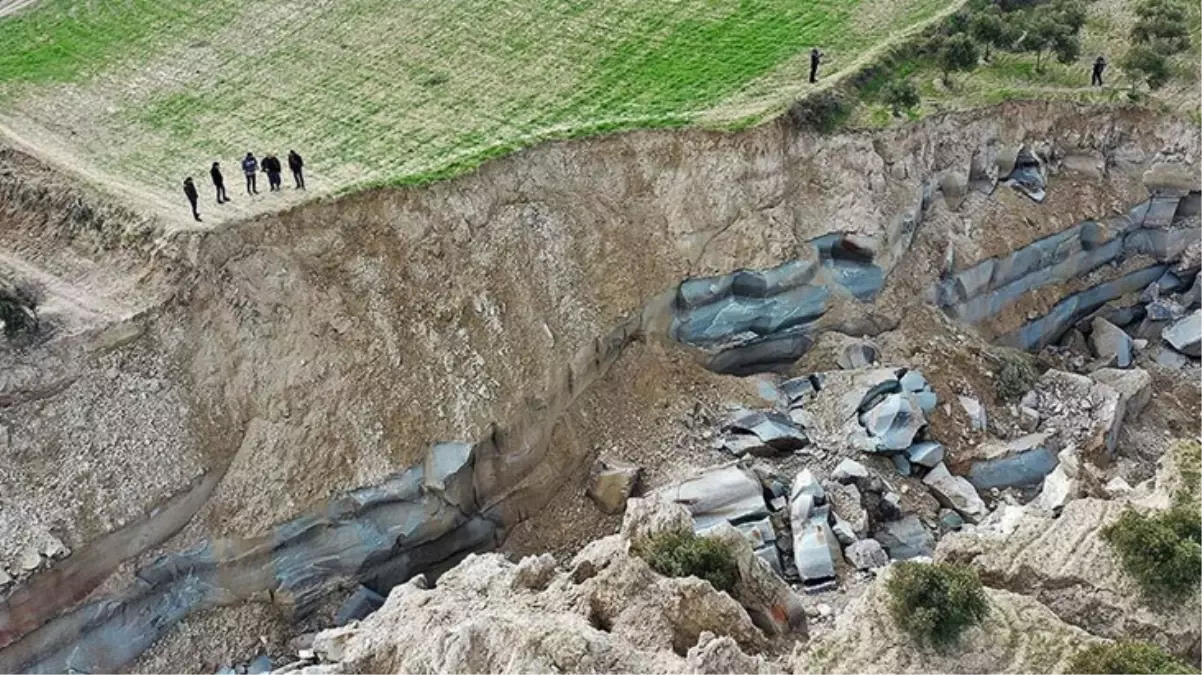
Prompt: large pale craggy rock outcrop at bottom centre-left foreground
<box><xmin>274</xmin><ymin>498</ymin><xmax>804</xmax><ymax>675</ymax></box>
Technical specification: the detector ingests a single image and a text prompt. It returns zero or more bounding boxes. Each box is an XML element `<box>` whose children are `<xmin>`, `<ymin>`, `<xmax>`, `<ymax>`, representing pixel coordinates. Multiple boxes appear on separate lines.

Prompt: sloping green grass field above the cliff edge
<box><xmin>0</xmin><ymin>0</ymin><xmax>958</xmax><ymax>214</ymax></box>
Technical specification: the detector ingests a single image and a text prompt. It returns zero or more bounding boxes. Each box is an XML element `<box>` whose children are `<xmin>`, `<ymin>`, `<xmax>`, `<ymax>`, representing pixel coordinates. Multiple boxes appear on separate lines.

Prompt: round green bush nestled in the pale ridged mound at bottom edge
<box><xmin>886</xmin><ymin>562</ymin><xmax>989</xmax><ymax>646</ymax></box>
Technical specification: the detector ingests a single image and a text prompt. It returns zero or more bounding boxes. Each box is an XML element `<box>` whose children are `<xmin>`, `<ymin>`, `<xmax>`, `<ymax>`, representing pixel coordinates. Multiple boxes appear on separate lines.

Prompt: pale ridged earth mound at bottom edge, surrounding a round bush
<box><xmin>791</xmin><ymin>564</ymin><xmax>1096</xmax><ymax>675</ymax></box>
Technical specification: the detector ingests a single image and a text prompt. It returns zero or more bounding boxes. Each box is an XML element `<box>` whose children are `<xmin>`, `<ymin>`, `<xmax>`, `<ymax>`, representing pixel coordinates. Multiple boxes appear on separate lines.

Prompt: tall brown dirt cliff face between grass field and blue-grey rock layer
<box><xmin>0</xmin><ymin>104</ymin><xmax>1202</xmax><ymax>672</ymax></box>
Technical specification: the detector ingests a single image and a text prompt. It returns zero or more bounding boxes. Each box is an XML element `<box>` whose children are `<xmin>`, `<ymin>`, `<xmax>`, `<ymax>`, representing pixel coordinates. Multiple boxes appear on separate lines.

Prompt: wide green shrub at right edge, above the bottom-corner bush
<box><xmin>1102</xmin><ymin>504</ymin><xmax>1202</xmax><ymax>599</ymax></box>
